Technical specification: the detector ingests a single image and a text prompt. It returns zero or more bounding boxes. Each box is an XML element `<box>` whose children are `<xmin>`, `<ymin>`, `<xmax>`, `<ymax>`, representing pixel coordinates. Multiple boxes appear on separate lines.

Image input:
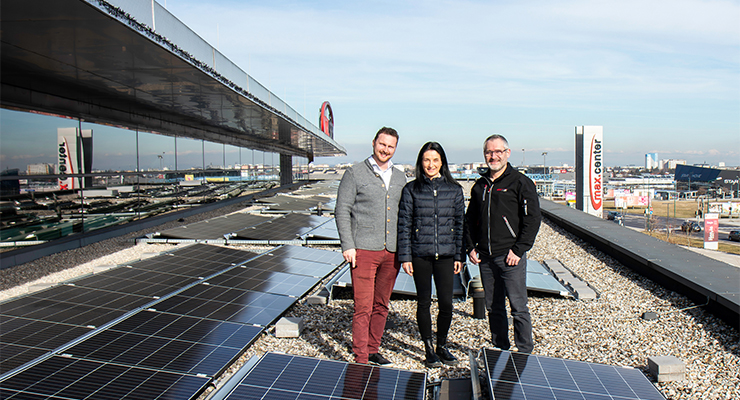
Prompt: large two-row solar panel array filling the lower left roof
<box><xmin>0</xmin><ymin>244</ymin><xmax>343</xmax><ymax>399</ymax></box>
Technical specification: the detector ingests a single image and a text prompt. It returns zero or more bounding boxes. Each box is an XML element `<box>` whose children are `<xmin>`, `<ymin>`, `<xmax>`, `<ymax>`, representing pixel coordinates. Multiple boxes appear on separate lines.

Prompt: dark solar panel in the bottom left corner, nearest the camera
<box><xmin>0</xmin><ymin>356</ymin><xmax>211</xmax><ymax>400</ymax></box>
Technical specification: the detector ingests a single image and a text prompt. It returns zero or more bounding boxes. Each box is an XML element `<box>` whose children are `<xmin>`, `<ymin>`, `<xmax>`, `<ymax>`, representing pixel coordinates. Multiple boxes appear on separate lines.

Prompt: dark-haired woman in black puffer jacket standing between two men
<box><xmin>398</xmin><ymin>142</ymin><xmax>465</xmax><ymax>367</ymax></box>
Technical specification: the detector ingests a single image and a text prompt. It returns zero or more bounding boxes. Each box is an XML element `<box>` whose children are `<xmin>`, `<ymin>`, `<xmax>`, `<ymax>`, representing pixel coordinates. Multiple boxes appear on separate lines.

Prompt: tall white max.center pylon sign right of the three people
<box><xmin>576</xmin><ymin>126</ymin><xmax>604</xmax><ymax>217</ymax></box>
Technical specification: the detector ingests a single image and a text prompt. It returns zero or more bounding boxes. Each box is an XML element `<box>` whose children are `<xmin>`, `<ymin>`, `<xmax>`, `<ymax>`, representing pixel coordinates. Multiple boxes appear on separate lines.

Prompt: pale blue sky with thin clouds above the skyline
<box><xmin>0</xmin><ymin>0</ymin><xmax>740</xmax><ymax>166</ymax></box>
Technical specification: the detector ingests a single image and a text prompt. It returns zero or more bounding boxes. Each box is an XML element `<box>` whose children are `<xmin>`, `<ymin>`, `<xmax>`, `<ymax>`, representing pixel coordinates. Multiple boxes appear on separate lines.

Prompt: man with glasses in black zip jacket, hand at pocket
<box><xmin>465</xmin><ymin>135</ymin><xmax>542</xmax><ymax>353</ymax></box>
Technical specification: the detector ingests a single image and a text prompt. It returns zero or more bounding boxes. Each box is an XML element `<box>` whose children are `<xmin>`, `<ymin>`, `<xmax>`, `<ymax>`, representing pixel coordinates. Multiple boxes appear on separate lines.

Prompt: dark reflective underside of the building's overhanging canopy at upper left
<box><xmin>0</xmin><ymin>0</ymin><xmax>345</xmax><ymax>160</ymax></box>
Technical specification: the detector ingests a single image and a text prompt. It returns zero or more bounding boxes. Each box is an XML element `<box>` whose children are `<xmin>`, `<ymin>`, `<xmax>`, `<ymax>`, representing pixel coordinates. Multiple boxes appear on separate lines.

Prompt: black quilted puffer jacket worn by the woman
<box><xmin>398</xmin><ymin>176</ymin><xmax>465</xmax><ymax>262</ymax></box>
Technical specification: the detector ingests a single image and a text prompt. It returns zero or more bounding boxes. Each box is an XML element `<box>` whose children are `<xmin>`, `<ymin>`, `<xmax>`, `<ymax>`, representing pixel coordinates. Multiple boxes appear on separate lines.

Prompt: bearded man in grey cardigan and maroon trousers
<box><xmin>334</xmin><ymin>127</ymin><xmax>406</xmax><ymax>366</ymax></box>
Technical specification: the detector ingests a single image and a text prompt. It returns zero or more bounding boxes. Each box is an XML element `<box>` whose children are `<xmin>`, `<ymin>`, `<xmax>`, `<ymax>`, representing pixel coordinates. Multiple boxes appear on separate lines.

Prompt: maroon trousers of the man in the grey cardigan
<box><xmin>352</xmin><ymin>249</ymin><xmax>401</xmax><ymax>364</ymax></box>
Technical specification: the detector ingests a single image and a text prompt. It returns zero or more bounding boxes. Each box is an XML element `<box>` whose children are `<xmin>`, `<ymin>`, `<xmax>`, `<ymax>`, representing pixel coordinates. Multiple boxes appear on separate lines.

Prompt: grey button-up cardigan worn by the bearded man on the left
<box><xmin>334</xmin><ymin>159</ymin><xmax>406</xmax><ymax>252</ymax></box>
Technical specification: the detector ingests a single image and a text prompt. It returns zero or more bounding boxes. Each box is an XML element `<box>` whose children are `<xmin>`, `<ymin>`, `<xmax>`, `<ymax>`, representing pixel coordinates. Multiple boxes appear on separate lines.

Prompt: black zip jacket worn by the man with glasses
<box><xmin>465</xmin><ymin>163</ymin><xmax>542</xmax><ymax>257</ymax></box>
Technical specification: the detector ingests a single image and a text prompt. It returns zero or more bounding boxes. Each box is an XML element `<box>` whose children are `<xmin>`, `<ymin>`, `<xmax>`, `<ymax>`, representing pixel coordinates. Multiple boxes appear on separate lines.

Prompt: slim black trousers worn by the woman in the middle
<box><xmin>412</xmin><ymin>256</ymin><xmax>455</xmax><ymax>340</ymax></box>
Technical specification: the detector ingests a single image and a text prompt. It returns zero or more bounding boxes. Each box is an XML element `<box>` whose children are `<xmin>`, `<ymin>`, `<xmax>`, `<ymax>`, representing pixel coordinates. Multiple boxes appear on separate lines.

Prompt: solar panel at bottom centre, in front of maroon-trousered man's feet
<box><xmin>214</xmin><ymin>353</ymin><xmax>426</xmax><ymax>400</ymax></box>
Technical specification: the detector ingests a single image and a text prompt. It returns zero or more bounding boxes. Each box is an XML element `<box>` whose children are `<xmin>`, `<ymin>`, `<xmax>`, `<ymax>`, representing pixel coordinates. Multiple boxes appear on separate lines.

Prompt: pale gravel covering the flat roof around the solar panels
<box><xmin>0</xmin><ymin>211</ymin><xmax>740</xmax><ymax>400</ymax></box>
